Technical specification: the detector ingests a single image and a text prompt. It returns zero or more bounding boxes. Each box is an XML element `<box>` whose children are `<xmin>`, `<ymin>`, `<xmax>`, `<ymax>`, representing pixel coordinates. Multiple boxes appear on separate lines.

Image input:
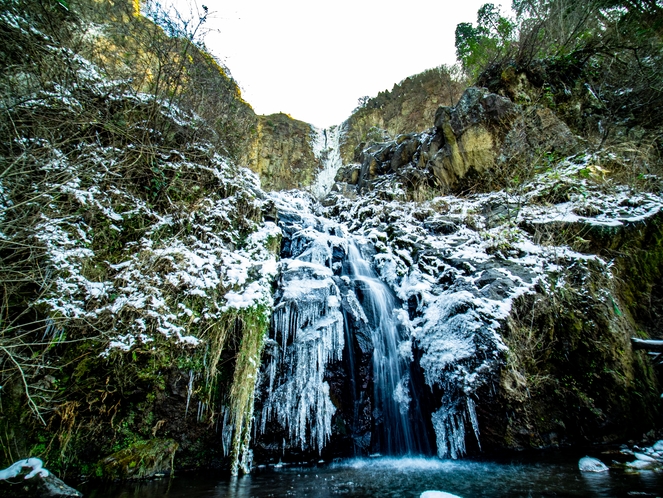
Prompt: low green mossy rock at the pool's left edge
<box><xmin>96</xmin><ymin>439</ymin><xmax>179</xmax><ymax>480</ymax></box>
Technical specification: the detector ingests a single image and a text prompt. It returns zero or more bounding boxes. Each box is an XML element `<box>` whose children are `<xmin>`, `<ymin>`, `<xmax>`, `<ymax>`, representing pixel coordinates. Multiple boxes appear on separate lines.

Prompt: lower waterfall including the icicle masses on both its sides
<box><xmin>257</xmin><ymin>193</ymin><xmax>488</xmax><ymax>458</ymax></box>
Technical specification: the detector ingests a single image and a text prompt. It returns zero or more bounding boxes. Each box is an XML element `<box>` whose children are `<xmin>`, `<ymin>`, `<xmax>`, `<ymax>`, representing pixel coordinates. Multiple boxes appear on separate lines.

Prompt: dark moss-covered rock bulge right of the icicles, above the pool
<box><xmin>501</xmin><ymin>255</ymin><xmax>657</xmax><ymax>447</ymax></box>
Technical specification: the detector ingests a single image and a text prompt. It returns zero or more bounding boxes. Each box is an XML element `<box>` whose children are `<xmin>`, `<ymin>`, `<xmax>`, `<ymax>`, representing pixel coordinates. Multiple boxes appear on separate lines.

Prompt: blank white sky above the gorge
<box><xmin>164</xmin><ymin>0</ymin><xmax>490</xmax><ymax>127</ymax></box>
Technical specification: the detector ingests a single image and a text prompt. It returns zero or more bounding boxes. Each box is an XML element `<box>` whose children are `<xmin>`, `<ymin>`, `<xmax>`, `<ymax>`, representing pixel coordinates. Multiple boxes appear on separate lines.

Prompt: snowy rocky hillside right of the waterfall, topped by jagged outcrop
<box><xmin>324</xmin><ymin>84</ymin><xmax>662</xmax><ymax>456</ymax></box>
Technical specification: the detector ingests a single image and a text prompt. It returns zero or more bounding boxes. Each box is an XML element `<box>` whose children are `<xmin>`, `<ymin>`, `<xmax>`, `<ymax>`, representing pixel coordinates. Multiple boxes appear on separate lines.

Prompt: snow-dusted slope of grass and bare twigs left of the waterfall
<box><xmin>0</xmin><ymin>12</ymin><xmax>281</xmax><ymax>474</ymax></box>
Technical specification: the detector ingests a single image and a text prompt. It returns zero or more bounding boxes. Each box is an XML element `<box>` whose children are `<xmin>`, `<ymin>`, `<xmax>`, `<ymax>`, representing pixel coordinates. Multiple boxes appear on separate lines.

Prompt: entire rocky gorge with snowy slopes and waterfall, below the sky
<box><xmin>0</xmin><ymin>0</ymin><xmax>663</xmax><ymax>496</ymax></box>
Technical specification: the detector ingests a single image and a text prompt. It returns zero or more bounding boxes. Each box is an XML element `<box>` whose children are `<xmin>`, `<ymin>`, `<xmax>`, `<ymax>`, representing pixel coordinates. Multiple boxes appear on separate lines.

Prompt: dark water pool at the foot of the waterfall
<box><xmin>79</xmin><ymin>453</ymin><xmax>663</xmax><ymax>498</ymax></box>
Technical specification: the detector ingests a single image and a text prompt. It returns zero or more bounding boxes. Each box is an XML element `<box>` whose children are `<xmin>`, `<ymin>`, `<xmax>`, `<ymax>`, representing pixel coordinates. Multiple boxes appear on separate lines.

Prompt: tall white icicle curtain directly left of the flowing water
<box><xmin>260</xmin><ymin>195</ymin><xmax>345</xmax><ymax>451</ymax></box>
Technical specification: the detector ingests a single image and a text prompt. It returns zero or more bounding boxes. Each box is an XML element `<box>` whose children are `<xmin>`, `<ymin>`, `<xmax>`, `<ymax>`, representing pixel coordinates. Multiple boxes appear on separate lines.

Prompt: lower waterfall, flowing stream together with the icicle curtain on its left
<box><xmin>258</xmin><ymin>194</ymin><xmax>430</xmax><ymax>455</ymax></box>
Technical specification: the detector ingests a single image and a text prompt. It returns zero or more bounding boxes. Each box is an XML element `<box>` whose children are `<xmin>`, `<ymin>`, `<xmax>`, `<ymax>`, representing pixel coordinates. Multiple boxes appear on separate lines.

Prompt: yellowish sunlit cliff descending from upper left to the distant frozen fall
<box><xmin>73</xmin><ymin>0</ymin><xmax>320</xmax><ymax>190</ymax></box>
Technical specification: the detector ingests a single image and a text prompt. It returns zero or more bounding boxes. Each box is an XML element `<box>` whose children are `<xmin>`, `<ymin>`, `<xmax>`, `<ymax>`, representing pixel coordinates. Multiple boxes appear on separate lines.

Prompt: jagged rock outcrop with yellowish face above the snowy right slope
<box><xmin>337</xmin><ymin>87</ymin><xmax>577</xmax><ymax>191</ymax></box>
